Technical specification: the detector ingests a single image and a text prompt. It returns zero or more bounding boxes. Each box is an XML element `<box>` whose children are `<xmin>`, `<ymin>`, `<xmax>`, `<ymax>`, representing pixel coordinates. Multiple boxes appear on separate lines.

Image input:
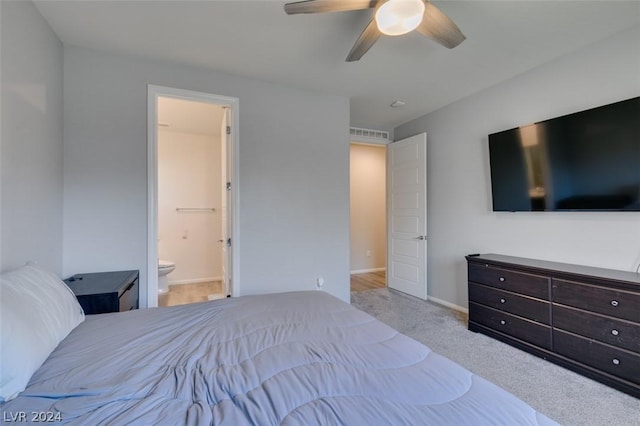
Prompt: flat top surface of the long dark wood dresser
<box><xmin>466</xmin><ymin>253</ymin><xmax>640</xmax><ymax>286</ymax></box>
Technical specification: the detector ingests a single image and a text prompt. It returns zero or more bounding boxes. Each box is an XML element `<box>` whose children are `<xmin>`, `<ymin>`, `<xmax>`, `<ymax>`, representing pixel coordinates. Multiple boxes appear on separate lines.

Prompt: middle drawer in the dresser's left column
<box><xmin>469</xmin><ymin>283</ymin><xmax>551</xmax><ymax>325</ymax></box>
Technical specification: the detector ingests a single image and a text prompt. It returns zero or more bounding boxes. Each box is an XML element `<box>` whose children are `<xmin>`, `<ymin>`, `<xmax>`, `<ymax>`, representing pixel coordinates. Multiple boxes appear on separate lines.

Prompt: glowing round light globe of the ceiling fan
<box><xmin>375</xmin><ymin>0</ymin><xmax>424</xmax><ymax>36</ymax></box>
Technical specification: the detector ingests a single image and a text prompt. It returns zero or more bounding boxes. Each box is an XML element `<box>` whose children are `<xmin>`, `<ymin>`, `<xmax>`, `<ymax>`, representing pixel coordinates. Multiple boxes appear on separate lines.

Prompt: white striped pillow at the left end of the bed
<box><xmin>0</xmin><ymin>265</ymin><xmax>84</xmax><ymax>402</ymax></box>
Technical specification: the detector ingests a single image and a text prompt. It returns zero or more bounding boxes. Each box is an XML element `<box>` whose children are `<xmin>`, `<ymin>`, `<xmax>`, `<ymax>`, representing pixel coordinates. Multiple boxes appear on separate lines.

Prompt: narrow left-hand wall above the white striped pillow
<box><xmin>0</xmin><ymin>1</ymin><xmax>63</xmax><ymax>274</ymax></box>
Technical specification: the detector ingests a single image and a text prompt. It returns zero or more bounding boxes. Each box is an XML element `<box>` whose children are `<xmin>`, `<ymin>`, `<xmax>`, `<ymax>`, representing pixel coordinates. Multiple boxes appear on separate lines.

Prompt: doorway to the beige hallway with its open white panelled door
<box><xmin>350</xmin><ymin>133</ymin><xmax>428</xmax><ymax>300</ymax></box>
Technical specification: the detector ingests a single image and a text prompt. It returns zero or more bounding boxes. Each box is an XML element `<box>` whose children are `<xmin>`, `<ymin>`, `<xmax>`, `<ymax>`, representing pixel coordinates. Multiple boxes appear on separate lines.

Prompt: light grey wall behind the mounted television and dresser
<box><xmin>395</xmin><ymin>27</ymin><xmax>640</xmax><ymax>307</ymax></box>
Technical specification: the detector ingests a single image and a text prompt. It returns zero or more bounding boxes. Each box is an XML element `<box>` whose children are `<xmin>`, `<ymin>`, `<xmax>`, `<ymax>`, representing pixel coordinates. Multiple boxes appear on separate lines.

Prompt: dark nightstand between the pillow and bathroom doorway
<box><xmin>64</xmin><ymin>271</ymin><xmax>139</xmax><ymax>315</ymax></box>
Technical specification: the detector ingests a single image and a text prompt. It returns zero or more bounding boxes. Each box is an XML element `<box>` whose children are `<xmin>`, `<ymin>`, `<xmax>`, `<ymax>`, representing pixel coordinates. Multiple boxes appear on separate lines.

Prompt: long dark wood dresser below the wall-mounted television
<box><xmin>466</xmin><ymin>254</ymin><xmax>640</xmax><ymax>398</ymax></box>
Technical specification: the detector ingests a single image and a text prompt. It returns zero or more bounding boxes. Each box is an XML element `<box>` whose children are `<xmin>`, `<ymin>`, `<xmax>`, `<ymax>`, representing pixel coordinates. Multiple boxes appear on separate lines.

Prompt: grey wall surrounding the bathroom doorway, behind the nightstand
<box><xmin>63</xmin><ymin>47</ymin><xmax>349</xmax><ymax>306</ymax></box>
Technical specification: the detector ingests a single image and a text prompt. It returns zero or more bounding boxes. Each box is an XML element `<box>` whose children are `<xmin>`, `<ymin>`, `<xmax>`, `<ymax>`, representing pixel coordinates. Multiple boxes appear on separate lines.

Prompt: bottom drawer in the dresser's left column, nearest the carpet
<box><xmin>469</xmin><ymin>302</ymin><xmax>551</xmax><ymax>349</ymax></box>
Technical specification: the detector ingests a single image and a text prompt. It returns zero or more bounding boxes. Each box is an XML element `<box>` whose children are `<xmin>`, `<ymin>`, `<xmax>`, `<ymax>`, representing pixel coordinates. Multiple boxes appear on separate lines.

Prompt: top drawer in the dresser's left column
<box><xmin>469</xmin><ymin>262</ymin><xmax>549</xmax><ymax>300</ymax></box>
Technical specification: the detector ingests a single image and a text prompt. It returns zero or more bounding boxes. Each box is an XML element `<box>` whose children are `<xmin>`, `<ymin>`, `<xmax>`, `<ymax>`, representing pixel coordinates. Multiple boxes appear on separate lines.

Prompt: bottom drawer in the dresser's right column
<box><xmin>553</xmin><ymin>329</ymin><xmax>640</xmax><ymax>384</ymax></box>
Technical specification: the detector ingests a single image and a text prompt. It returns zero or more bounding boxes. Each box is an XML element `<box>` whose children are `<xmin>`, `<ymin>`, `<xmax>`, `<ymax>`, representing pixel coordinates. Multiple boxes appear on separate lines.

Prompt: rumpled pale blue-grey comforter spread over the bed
<box><xmin>0</xmin><ymin>264</ymin><xmax>555</xmax><ymax>425</ymax></box>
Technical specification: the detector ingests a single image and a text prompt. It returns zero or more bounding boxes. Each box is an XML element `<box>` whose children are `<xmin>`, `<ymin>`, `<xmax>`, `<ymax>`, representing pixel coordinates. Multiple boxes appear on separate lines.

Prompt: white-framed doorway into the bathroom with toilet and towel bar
<box><xmin>147</xmin><ymin>86</ymin><xmax>237</xmax><ymax>306</ymax></box>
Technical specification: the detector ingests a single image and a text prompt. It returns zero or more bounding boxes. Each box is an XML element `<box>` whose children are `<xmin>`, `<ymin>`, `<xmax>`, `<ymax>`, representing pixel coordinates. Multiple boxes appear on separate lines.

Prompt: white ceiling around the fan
<box><xmin>36</xmin><ymin>0</ymin><xmax>640</xmax><ymax>129</ymax></box>
